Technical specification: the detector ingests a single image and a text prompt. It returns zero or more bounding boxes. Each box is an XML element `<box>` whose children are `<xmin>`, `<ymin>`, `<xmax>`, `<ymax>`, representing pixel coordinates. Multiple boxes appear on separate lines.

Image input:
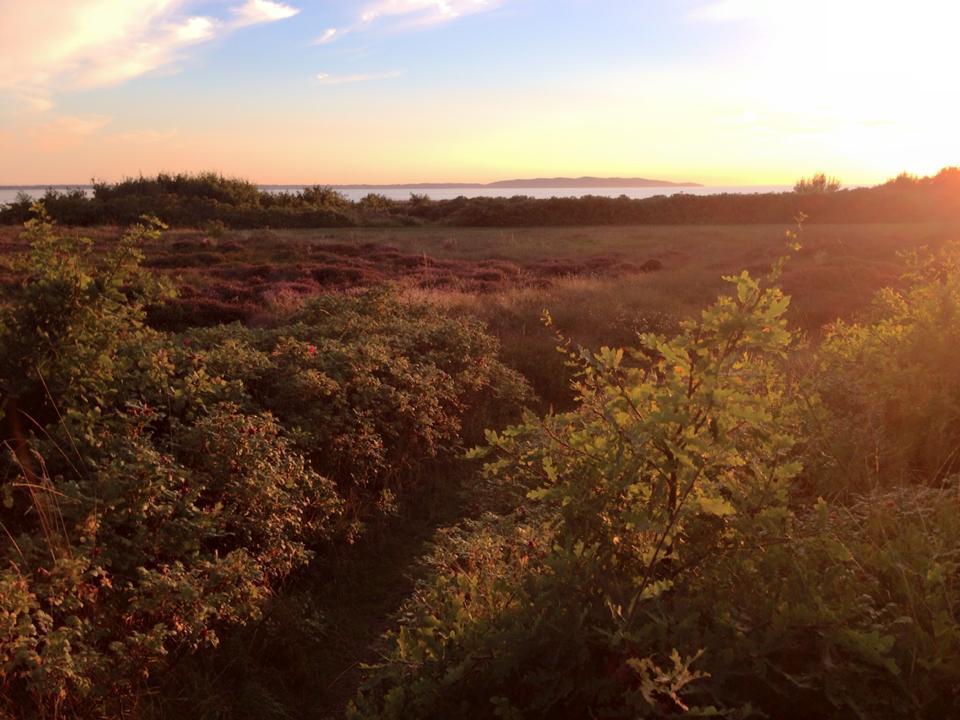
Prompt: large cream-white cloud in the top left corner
<box><xmin>0</xmin><ymin>0</ymin><xmax>299</xmax><ymax>105</ymax></box>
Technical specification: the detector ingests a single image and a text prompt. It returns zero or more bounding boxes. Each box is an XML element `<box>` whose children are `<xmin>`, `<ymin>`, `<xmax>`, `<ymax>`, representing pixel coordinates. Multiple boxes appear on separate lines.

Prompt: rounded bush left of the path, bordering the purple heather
<box><xmin>175</xmin><ymin>288</ymin><xmax>528</xmax><ymax>504</ymax></box>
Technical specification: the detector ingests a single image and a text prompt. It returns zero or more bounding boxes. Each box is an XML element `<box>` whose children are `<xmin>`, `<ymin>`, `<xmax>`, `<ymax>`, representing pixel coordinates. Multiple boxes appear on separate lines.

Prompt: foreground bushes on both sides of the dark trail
<box><xmin>0</xmin><ymin>207</ymin><xmax>960</xmax><ymax>720</ymax></box>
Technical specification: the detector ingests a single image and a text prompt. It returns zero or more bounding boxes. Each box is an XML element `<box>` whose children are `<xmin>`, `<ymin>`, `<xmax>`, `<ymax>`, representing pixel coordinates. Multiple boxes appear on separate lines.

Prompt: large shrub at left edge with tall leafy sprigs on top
<box><xmin>0</xmin><ymin>212</ymin><xmax>339</xmax><ymax>716</ymax></box>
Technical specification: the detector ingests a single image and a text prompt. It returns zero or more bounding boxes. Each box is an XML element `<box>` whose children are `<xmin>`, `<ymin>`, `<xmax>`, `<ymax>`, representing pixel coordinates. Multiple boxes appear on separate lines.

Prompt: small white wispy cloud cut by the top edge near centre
<box><xmin>313</xmin><ymin>0</ymin><xmax>507</xmax><ymax>45</ymax></box>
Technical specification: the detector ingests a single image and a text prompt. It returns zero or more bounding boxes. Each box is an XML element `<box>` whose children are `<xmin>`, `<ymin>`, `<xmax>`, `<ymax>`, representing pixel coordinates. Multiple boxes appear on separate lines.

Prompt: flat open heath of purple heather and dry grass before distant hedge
<box><xmin>0</xmin><ymin>223</ymin><xmax>960</xmax><ymax>330</ymax></box>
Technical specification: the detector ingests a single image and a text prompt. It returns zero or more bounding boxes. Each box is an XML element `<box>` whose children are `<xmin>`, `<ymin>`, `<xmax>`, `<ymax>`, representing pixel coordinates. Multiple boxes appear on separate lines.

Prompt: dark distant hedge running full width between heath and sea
<box><xmin>0</xmin><ymin>168</ymin><xmax>960</xmax><ymax>228</ymax></box>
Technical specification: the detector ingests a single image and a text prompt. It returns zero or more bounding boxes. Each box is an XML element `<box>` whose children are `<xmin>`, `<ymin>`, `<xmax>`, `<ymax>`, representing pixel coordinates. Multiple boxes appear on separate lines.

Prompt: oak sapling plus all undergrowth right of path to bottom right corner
<box><xmin>351</xmin><ymin>256</ymin><xmax>960</xmax><ymax>720</ymax></box>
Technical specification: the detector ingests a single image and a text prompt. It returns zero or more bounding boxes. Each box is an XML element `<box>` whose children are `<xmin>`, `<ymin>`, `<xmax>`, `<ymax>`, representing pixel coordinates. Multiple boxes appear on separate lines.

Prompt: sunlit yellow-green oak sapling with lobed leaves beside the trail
<box><xmin>348</xmin><ymin>258</ymin><xmax>800</xmax><ymax>718</ymax></box>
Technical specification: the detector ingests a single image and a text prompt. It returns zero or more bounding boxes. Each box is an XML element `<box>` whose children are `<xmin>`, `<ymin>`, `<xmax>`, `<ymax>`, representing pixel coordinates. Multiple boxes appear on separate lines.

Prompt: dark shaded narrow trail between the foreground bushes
<box><xmin>152</xmin><ymin>466</ymin><xmax>478</xmax><ymax>720</ymax></box>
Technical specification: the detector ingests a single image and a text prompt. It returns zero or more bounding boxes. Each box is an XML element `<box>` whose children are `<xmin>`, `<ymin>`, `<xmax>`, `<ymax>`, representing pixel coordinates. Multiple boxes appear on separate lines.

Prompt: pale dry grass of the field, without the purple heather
<box><xmin>256</xmin><ymin>223</ymin><xmax>960</xmax><ymax>407</ymax></box>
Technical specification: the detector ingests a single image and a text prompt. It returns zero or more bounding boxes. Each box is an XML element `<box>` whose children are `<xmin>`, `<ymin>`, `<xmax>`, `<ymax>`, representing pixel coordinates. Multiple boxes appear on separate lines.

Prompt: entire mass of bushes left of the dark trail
<box><xmin>0</xmin><ymin>211</ymin><xmax>523</xmax><ymax>717</ymax></box>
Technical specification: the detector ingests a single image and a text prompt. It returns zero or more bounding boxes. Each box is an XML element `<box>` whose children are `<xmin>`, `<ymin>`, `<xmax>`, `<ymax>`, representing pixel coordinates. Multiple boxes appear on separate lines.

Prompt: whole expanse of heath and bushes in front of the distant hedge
<box><xmin>0</xmin><ymin>205</ymin><xmax>960</xmax><ymax>720</ymax></box>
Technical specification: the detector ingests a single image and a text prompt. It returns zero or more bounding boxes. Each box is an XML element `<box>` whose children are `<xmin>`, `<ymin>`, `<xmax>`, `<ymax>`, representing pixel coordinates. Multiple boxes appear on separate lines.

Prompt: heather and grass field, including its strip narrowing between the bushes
<box><xmin>7</xmin><ymin>222</ymin><xmax>960</xmax><ymax>406</ymax></box>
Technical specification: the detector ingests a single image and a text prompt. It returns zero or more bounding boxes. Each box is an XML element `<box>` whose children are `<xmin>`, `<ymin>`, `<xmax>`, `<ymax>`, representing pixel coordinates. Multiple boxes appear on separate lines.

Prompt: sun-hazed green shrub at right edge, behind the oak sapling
<box><xmin>817</xmin><ymin>247</ymin><xmax>960</xmax><ymax>494</ymax></box>
